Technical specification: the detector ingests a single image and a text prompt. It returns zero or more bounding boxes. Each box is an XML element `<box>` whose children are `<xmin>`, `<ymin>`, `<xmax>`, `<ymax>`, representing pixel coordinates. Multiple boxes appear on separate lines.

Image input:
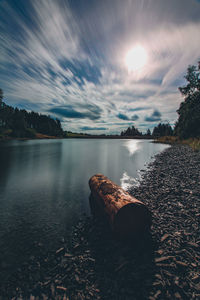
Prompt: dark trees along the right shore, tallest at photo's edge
<box><xmin>121</xmin><ymin>62</ymin><xmax>200</xmax><ymax>139</ymax></box>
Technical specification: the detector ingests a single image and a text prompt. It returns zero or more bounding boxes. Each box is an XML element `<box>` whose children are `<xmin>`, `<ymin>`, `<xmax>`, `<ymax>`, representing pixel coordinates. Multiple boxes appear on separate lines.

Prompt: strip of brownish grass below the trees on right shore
<box><xmin>155</xmin><ymin>136</ymin><xmax>200</xmax><ymax>151</ymax></box>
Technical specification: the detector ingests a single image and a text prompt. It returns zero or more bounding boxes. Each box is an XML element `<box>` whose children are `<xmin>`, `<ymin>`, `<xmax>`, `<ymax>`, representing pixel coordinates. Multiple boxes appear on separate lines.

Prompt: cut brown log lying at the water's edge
<box><xmin>89</xmin><ymin>174</ymin><xmax>151</xmax><ymax>239</ymax></box>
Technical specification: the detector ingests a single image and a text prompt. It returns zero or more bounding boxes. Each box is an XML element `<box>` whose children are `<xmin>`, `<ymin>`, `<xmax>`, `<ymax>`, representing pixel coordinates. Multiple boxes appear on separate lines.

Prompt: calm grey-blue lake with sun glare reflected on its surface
<box><xmin>0</xmin><ymin>139</ymin><xmax>169</xmax><ymax>271</ymax></box>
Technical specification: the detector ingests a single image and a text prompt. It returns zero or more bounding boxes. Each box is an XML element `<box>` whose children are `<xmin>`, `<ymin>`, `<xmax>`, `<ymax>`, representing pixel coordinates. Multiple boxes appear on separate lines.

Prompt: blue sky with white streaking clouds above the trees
<box><xmin>0</xmin><ymin>0</ymin><xmax>200</xmax><ymax>134</ymax></box>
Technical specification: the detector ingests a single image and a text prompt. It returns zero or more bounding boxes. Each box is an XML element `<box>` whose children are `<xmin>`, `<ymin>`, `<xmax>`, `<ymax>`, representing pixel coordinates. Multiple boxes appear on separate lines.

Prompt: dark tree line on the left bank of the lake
<box><xmin>0</xmin><ymin>89</ymin><xmax>63</xmax><ymax>138</ymax></box>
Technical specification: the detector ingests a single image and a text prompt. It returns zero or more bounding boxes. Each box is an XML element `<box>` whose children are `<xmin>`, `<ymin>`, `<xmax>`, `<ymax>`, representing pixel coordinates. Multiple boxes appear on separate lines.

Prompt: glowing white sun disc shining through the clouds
<box><xmin>125</xmin><ymin>45</ymin><xmax>147</xmax><ymax>72</ymax></box>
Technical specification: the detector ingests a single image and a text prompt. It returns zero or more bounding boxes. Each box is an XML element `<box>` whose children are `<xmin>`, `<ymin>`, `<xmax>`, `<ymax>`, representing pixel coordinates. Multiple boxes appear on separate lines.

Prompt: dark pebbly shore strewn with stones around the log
<box><xmin>0</xmin><ymin>145</ymin><xmax>200</xmax><ymax>300</ymax></box>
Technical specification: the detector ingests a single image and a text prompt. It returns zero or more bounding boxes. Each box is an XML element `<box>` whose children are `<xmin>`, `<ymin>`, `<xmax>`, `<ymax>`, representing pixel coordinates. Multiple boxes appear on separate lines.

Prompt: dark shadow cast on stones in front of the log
<box><xmin>85</xmin><ymin>220</ymin><xmax>156</xmax><ymax>300</ymax></box>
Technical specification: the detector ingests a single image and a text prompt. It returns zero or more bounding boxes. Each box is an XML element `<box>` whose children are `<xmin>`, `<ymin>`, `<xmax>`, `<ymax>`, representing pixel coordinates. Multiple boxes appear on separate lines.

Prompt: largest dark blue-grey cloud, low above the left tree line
<box><xmin>49</xmin><ymin>106</ymin><xmax>101</xmax><ymax>120</ymax></box>
